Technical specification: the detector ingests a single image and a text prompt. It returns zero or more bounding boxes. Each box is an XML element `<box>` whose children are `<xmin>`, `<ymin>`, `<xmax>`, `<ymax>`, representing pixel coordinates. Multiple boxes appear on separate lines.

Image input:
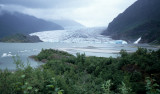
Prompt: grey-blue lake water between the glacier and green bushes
<box><xmin>0</xmin><ymin>42</ymin><xmax>158</xmax><ymax>70</ymax></box>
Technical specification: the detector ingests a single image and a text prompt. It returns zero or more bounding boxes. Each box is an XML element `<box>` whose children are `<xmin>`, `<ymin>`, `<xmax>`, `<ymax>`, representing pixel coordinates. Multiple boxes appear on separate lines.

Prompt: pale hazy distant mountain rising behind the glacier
<box><xmin>53</xmin><ymin>19</ymin><xmax>85</xmax><ymax>29</ymax></box>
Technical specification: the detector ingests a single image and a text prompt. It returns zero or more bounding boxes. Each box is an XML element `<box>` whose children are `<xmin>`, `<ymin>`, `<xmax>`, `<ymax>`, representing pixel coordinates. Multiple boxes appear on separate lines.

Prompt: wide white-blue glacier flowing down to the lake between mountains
<box><xmin>30</xmin><ymin>28</ymin><xmax>127</xmax><ymax>44</ymax></box>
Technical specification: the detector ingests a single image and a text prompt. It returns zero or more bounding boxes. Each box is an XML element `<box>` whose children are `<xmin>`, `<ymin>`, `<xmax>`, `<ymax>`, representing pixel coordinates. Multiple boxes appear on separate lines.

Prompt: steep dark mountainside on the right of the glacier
<box><xmin>102</xmin><ymin>0</ymin><xmax>160</xmax><ymax>43</ymax></box>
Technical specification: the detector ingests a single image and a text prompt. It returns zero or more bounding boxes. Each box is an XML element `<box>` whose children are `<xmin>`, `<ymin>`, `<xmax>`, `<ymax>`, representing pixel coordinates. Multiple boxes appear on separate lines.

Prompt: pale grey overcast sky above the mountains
<box><xmin>0</xmin><ymin>0</ymin><xmax>137</xmax><ymax>27</ymax></box>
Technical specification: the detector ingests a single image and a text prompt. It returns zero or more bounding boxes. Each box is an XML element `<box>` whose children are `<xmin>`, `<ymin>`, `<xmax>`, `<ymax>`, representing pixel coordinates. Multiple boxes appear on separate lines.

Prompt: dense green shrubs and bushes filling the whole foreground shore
<box><xmin>0</xmin><ymin>48</ymin><xmax>160</xmax><ymax>94</ymax></box>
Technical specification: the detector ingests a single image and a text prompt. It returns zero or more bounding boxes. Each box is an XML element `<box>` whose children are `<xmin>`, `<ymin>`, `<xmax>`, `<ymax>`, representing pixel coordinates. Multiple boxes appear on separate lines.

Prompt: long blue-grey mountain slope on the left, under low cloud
<box><xmin>0</xmin><ymin>11</ymin><xmax>64</xmax><ymax>37</ymax></box>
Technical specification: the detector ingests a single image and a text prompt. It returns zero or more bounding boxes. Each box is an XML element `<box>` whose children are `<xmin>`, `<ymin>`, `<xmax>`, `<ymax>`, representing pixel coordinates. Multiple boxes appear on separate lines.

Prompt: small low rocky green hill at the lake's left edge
<box><xmin>0</xmin><ymin>34</ymin><xmax>42</xmax><ymax>43</ymax></box>
